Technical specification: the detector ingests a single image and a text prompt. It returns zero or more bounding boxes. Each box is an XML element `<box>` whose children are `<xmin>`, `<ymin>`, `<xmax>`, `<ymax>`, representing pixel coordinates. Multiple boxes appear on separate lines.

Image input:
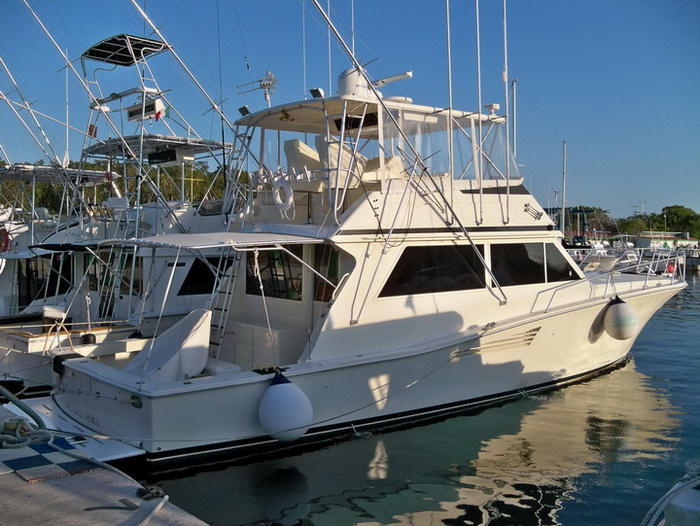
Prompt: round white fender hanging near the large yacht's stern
<box><xmin>258</xmin><ymin>372</ymin><xmax>314</xmax><ymax>442</ymax></box>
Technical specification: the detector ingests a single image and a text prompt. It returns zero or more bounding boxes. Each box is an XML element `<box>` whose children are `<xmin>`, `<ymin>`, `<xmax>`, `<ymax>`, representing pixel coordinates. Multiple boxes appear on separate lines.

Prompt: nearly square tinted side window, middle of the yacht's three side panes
<box><xmin>491</xmin><ymin>243</ymin><xmax>544</xmax><ymax>287</ymax></box>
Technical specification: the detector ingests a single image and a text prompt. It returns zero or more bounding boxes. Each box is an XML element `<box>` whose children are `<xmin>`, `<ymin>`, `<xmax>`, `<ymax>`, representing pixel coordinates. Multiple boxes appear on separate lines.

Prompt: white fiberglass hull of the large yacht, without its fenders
<box><xmin>45</xmin><ymin>285</ymin><xmax>683</xmax><ymax>466</ymax></box>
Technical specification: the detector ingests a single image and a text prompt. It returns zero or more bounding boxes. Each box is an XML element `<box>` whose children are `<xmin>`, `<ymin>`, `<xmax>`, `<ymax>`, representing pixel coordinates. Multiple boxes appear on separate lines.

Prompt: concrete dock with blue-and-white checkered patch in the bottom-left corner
<box><xmin>0</xmin><ymin>408</ymin><xmax>206</xmax><ymax>526</ymax></box>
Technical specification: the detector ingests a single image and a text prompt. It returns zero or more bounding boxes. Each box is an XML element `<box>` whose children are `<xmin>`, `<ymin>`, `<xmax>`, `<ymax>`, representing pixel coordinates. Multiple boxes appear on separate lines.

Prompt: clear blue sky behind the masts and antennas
<box><xmin>0</xmin><ymin>0</ymin><xmax>700</xmax><ymax>216</ymax></box>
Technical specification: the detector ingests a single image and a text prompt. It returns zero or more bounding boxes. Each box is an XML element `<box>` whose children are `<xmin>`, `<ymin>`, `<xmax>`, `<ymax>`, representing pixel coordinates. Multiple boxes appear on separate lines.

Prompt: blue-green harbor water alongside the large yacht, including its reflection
<box><xmin>150</xmin><ymin>277</ymin><xmax>700</xmax><ymax>526</ymax></box>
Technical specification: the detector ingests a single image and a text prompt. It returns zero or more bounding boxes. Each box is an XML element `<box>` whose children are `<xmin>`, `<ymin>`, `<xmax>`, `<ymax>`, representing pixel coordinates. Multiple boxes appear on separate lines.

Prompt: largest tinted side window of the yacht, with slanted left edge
<box><xmin>379</xmin><ymin>245</ymin><xmax>485</xmax><ymax>297</ymax></box>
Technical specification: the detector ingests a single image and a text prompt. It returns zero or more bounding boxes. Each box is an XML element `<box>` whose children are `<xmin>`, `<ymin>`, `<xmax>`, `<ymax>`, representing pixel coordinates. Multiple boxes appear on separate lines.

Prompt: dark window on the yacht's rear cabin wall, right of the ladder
<box><xmin>246</xmin><ymin>245</ymin><xmax>303</xmax><ymax>301</ymax></box>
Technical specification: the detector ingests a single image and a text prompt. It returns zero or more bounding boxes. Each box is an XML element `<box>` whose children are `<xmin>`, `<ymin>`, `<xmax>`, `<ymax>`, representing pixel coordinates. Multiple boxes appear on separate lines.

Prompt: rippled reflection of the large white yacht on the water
<box><xmin>157</xmin><ymin>362</ymin><xmax>679</xmax><ymax>525</ymax></box>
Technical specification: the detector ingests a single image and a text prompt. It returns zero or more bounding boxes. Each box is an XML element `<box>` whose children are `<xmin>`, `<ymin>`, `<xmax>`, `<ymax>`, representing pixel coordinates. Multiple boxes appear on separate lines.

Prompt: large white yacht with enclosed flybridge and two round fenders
<box><xmin>13</xmin><ymin>70</ymin><xmax>686</xmax><ymax>462</ymax></box>
